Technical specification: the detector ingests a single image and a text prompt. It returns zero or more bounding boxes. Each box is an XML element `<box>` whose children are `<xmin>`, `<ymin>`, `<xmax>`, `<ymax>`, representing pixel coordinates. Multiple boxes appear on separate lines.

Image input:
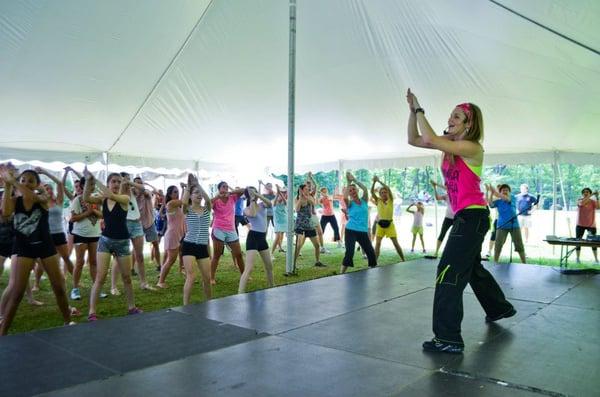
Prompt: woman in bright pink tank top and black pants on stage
<box><xmin>406</xmin><ymin>89</ymin><xmax>517</xmax><ymax>354</ymax></box>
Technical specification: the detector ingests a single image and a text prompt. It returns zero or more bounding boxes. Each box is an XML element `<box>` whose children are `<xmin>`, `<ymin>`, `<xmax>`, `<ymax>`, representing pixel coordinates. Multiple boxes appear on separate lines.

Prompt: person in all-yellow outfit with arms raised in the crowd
<box><xmin>371</xmin><ymin>175</ymin><xmax>404</xmax><ymax>262</ymax></box>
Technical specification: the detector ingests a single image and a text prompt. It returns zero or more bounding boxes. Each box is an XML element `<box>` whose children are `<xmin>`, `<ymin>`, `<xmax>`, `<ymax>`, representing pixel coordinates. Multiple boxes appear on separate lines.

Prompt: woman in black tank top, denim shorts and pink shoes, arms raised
<box><xmin>83</xmin><ymin>169</ymin><xmax>142</xmax><ymax>321</ymax></box>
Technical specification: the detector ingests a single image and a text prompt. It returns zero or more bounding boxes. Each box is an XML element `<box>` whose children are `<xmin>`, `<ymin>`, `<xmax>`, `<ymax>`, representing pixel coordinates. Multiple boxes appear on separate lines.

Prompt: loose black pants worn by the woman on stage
<box><xmin>433</xmin><ymin>209</ymin><xmax>513</xmax><ymax>345</ymax></box>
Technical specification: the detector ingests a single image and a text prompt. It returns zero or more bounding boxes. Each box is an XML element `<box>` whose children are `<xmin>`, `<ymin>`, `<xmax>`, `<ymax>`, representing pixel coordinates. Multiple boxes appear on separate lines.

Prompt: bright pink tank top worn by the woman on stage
<box><xmin>442</xmin><ymin>156</ymin><xmax>487</xmax><ymax>214</ymax></box>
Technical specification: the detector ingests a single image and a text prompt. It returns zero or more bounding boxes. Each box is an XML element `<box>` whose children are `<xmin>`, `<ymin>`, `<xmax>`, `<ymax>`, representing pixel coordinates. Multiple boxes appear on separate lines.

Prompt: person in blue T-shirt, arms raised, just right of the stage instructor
<box><xmin>488</xmin><ymin>184</ymin><xmax>526</xmax><ymax>263</ymax></box>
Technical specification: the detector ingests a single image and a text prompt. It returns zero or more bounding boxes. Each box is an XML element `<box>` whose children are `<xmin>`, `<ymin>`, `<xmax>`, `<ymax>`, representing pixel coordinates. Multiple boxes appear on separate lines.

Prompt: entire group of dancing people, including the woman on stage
<box><xmin>0</xmin><ymin>90</ymin><xmax>598</xmax><ymax>353</ymax></box>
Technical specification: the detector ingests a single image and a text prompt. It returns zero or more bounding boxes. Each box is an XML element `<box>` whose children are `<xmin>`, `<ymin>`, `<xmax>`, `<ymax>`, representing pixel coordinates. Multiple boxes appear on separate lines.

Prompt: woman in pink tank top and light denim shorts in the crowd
<box><xmin>210</xmin><ymin>182</ymin><xmax>244</xmax><ymax>284</ymax></box>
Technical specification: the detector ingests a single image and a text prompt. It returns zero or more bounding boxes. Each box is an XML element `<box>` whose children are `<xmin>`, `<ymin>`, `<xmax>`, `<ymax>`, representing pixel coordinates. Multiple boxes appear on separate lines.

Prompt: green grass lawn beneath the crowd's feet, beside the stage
<box><xmin>0</xmin><ymin>245</ymin><xmax>589</xmax><ymax>334</ymax></box>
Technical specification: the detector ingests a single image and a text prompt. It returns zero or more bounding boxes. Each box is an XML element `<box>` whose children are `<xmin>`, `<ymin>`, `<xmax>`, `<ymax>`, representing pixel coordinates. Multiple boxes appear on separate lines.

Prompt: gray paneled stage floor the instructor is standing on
<box><xmin>0</xmin><ymin>259</ymin><xmax>600</xmax><ymax>397</ymax></box>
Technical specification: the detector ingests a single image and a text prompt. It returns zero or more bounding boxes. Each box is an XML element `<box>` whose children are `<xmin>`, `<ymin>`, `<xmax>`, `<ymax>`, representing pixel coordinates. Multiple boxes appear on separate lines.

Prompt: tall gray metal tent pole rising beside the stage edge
<box><xmin>285</xmin><ymin>0</ymin><xmax>296</xmax><ymax>274</ymax></box>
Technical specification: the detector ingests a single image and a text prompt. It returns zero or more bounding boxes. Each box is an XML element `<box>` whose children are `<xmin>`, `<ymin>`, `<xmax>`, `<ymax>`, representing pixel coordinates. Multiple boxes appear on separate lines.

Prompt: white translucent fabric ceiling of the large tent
<box><xmin>0</xmin><ymin>0</ymin><xmax>600</xmax><ymax>170</ymax></box>
